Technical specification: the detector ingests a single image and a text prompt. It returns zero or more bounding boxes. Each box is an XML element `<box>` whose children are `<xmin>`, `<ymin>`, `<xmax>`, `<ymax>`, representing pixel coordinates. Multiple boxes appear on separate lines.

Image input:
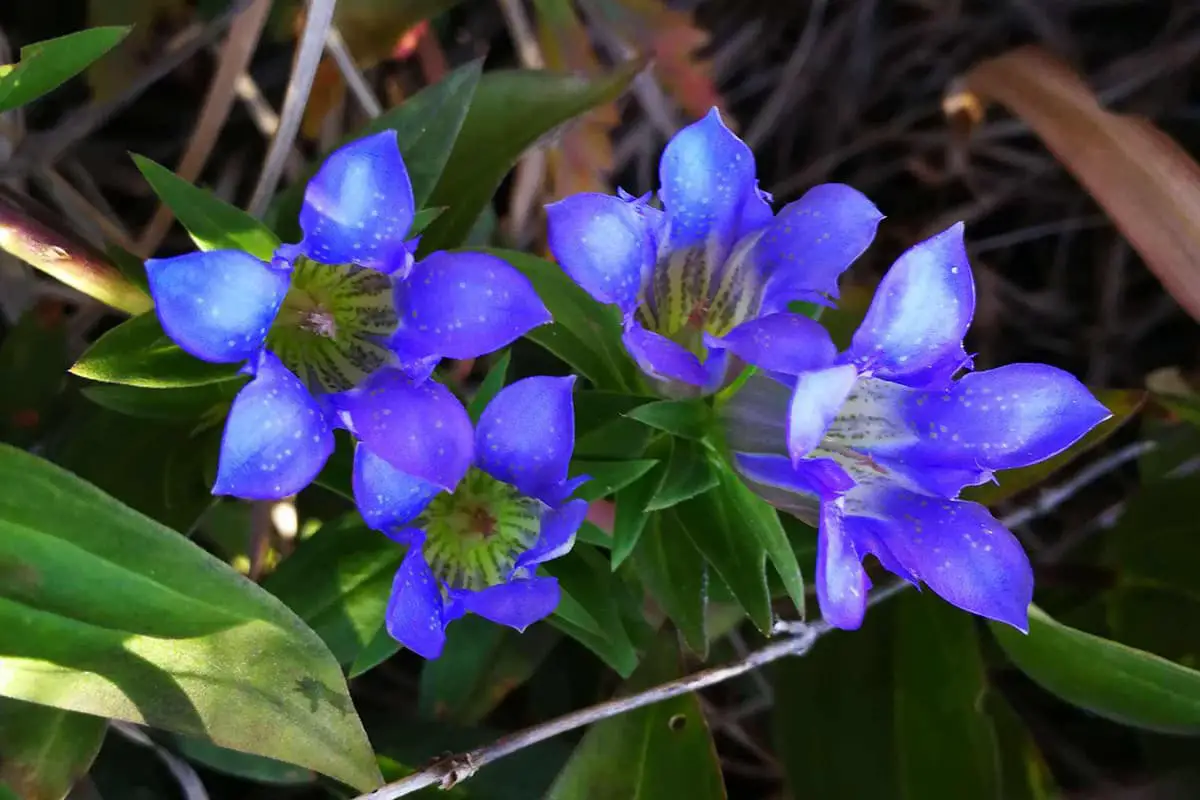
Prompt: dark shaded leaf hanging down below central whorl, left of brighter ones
<box><xmin>633</xmin><ymin>513</ymin><xmax>708</xmax><ymax>658</ymax></box>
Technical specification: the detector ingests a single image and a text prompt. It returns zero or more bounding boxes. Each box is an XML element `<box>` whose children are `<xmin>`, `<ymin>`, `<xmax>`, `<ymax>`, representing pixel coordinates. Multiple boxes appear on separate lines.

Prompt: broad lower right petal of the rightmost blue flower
<box><xmin>872</xmin><ymin>489</ymin><xmax>1033</xmax><ymax>631</ymax></box>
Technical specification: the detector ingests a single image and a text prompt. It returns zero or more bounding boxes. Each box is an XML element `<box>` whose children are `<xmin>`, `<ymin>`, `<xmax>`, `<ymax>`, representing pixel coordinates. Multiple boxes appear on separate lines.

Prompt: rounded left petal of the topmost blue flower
<box><xmin>546</xmin><ymin>193</ymin><xmax>654</xmax><ymax>312</ymax></box>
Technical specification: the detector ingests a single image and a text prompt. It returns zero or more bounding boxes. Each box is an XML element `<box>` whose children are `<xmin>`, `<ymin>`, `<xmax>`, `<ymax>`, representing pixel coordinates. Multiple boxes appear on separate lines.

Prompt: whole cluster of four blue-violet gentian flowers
<box><xmin>146</xmin><ymin>110</ymin><xmax>1108</xmax><ymax>658</ymax></box>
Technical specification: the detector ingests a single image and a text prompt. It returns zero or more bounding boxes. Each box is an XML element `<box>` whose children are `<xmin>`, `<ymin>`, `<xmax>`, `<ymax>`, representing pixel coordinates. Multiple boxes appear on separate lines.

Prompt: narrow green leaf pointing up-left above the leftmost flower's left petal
<box><xmin>132</xmin><ymin>155</ymin><xmax>280</xmax><ymax>261</ymax></box>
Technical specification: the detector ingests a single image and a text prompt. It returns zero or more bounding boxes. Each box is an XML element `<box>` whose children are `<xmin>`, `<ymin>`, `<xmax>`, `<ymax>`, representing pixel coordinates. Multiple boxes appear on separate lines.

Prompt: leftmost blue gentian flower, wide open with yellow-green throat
<box><xmin>146</xmin><ymin>131</ymin><xmax>550</xmax><ymax>499</ymax></box>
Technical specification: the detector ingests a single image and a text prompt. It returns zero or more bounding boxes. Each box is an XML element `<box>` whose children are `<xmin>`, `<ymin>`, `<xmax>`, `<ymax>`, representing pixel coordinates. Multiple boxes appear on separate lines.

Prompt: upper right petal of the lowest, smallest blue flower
<box><xmin>475</xmin><ymin>375</ymin><xmax>575</xmax><ymax>497</ymax></box>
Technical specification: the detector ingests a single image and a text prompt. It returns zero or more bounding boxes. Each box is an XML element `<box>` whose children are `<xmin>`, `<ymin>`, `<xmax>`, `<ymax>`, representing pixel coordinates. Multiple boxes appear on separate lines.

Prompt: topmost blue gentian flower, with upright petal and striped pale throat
<box><xmin>547</xmin><ymin>108</ymin><xmax>882</xmax><ymax>395</ymax></box>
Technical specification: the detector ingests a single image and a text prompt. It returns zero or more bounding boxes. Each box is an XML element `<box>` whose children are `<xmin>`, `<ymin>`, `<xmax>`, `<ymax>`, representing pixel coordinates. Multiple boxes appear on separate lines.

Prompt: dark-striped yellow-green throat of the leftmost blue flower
<box><xmin>266</xmin><ymin>257</ymin><xmax>396</xmax><ymax>392</ymax></box>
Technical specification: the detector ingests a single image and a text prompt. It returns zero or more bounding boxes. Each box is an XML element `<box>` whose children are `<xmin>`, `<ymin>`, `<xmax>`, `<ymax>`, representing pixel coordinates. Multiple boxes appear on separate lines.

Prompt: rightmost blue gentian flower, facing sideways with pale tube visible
<box><xmin>724</xmin><ymin>224</ymin><xmax>1110</xmax><ymax>631</ymax></box>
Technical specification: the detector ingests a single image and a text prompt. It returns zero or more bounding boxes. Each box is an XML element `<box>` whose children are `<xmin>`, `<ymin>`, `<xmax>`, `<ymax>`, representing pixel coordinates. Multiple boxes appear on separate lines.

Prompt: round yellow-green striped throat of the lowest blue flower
<box><xmin>415</xmin><ymin>469</ymin><xmax>545</xmax><ymax>591</ymax></box>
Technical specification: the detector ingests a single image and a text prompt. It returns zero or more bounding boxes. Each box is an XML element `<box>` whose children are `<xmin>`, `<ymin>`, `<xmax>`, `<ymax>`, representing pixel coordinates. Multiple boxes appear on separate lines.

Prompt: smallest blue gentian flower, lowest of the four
<box><xmin>354</xmin><ymin>373</ymin><xmax>588</xmax><ymax>658</ymax></box>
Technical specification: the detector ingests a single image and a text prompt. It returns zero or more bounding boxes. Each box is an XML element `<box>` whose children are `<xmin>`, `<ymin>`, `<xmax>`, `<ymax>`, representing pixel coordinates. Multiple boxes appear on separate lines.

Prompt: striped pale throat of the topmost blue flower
<box><xmin>636</xmin><ymin>231</ymin><xmax>763</xmax><ymax>356</ymax></box>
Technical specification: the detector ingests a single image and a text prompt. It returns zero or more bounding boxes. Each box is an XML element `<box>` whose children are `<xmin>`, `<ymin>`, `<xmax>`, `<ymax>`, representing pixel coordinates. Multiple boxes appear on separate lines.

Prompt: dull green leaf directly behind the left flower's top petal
<box><xmin>266</xmin><ymin>61</ymin><xmax>482</xmax><ymax>240</ymax></box>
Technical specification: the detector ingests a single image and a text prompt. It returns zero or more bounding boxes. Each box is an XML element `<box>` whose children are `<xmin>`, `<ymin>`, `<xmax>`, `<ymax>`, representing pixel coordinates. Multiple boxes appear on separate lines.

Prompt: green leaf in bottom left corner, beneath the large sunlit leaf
<box><xmin>0</xmin><ymin>697</ymin><xmax>108</xmax><ymax>800</ymax></box>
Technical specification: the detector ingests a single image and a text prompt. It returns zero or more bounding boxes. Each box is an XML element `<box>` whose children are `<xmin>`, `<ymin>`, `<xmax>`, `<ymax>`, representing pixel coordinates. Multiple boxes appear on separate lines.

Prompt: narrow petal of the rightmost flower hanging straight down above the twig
<box><xmin>816</xmin><ymin>499</ymin><xmax>871</xmax><ymax>631</ymax></box>
